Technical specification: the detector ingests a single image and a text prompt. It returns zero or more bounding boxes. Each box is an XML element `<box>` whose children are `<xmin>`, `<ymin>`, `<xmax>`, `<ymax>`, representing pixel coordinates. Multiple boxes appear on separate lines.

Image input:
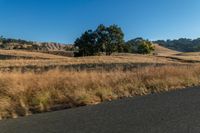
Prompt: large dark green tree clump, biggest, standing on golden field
<box><xmin>75</xmin><ymin>24</ymin><xmax>124</xmax><ymax>56</ymax></box>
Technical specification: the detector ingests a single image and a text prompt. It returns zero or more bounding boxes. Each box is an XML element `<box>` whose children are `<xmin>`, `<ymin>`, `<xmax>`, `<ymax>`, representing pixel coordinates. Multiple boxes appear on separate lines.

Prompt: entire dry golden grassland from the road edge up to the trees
<box><xmin>0</xmin><ymin>48</ymin><xmax>200</xmax><ymax>119</ymax></box>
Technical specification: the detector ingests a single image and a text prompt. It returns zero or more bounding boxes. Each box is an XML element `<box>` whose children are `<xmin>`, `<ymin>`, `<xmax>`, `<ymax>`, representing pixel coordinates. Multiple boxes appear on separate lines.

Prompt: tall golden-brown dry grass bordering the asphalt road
<box><xmin>0</xmin><ymin>65</ymin><xmax>200</xmax><ymax>119</ymax></box>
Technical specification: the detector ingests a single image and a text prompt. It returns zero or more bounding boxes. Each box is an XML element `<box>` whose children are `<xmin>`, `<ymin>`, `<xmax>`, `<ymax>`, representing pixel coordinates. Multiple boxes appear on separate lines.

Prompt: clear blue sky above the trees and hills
<box><xmin>0</xmin><ymin>0</ymin><xmax>200</xmax><ymax>43</ymax></box>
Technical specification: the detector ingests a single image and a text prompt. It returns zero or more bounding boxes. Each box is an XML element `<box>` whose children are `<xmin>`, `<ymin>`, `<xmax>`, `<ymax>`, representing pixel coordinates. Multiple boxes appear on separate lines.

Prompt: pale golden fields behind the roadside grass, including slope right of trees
<box><xmin>0</xmin><ymin>45</ymin><xmax>197</xmax><ymax>70</ymax></box>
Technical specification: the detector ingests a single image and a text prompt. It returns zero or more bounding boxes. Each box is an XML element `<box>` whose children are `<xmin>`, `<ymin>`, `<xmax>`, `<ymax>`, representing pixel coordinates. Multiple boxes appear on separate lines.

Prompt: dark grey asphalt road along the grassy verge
<box><xmin>0</xmin><ymin>87</ymin><xmax>200</xmax><ymax>133</ymax></box>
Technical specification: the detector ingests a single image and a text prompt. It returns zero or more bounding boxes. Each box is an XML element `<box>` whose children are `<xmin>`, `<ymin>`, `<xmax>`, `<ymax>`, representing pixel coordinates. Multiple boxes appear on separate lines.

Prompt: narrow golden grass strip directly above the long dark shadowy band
<box><xmin>0</xmin><ymin>54</ymin><xmax>179</xmax><ymax>70</ymax></box>
